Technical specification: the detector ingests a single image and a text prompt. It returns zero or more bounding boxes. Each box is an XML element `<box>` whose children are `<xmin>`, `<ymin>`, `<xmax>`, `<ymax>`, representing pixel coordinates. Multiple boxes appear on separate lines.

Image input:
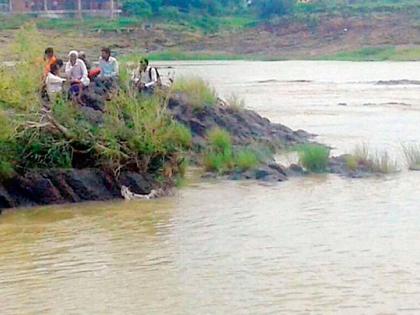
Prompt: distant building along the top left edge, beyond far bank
<box><xmin>0</xmin><ymin>0</ymin><xmax>121</xmax><ymax>17</ymax></box>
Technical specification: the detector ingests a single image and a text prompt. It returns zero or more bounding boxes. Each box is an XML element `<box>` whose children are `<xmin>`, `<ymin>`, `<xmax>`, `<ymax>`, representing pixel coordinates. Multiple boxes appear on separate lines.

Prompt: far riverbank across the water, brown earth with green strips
<box><xmin>0</xmin><ymin>11</ymin><xmax>420</xmax><ymax>61</ymax></box>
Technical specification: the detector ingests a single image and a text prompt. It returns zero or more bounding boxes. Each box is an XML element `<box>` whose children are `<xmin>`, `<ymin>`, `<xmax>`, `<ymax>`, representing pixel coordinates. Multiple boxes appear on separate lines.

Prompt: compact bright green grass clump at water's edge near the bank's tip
<box><xmin>298</xmin><ymin>144</ymin><xmax>330</xmax><ymax>173</ymax></box>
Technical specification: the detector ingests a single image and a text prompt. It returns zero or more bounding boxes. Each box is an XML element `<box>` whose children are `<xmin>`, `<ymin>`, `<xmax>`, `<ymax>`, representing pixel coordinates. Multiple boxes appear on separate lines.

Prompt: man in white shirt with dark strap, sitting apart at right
<box><xmin>131</xmin><ymin>58</ymin><xmax>162</xmax><ymax>94</ymax></box>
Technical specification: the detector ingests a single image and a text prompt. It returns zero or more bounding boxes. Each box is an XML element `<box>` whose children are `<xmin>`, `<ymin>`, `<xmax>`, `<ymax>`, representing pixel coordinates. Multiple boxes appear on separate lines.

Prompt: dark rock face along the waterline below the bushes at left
<box><xmin>0</xmin><ymin>169</ymin><xmax>157</xmax><ymax>209</ymax></box>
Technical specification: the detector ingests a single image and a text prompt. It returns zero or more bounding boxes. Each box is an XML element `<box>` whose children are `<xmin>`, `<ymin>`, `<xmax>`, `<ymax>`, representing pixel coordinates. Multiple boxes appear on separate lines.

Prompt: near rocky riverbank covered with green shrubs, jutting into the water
<box><xmin>0</xmin><ymin>25</ymin><xmax>316</xmax><ymax>208</ymax></box>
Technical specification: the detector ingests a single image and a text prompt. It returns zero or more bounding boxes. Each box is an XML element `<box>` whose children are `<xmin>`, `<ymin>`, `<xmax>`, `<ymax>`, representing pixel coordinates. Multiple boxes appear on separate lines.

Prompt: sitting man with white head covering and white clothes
<box><xmin>66</xmin><ymin>50</ymin><xmax>90</xmax><ymax>105</ymax></box>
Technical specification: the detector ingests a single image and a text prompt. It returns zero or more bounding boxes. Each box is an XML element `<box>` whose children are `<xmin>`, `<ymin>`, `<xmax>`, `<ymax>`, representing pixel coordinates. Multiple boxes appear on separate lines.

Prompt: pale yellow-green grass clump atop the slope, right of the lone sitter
<box><xmin>172</xmin><ymin>77</ymin><xmax>217</xmax><ymax>109</ymax></box>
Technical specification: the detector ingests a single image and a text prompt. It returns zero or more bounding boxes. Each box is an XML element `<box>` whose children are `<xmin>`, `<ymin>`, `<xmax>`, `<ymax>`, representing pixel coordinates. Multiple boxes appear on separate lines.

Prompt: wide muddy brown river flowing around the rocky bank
<box><xmin>0</xmin><ymin>61</ymin><xmax>420</xmax><ymax>314</ymax></box>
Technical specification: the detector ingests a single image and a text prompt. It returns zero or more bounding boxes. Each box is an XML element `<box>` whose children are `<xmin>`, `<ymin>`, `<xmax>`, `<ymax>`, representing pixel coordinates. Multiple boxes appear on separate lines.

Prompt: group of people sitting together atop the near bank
<box><xmin>43</xmin><ymin>47</ymin><xmax>161</xmax><ymax>105</ymax></box>
